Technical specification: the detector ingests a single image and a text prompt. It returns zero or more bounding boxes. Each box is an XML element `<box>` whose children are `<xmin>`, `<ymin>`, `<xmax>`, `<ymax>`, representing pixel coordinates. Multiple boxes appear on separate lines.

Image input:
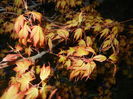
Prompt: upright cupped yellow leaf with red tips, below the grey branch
<box><xmin>40</xmin><ymin>65</ymin><xmax>51</xmax><ymax>80</ymax></box>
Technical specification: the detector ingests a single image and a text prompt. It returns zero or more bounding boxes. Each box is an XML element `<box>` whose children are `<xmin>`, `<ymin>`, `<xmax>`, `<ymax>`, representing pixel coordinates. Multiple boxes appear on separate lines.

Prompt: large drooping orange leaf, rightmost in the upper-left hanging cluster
<box><xmin>30</xmin><ymin>26</ymin><xmax>45</xmax><ymax>47</ymax></box>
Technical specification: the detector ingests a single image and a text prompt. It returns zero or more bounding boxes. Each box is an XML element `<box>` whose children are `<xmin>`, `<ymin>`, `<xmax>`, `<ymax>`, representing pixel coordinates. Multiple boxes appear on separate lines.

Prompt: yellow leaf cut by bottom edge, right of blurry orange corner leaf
<box><xmin>25</xmin><ymin>86</ymin><xmax>38</xmax><ymax>99</ymax></box>
